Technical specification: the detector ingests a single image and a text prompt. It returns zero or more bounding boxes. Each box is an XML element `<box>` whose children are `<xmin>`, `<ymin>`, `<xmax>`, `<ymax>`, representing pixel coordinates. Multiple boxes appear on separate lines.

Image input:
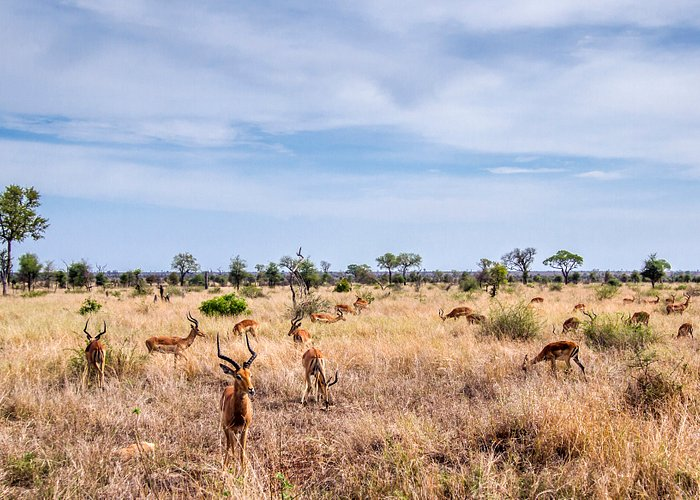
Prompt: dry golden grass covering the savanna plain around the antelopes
<box><xmin>0</xmin><ymin>285</ymin><xmax>700</xmax><ymax>498</ymax></box>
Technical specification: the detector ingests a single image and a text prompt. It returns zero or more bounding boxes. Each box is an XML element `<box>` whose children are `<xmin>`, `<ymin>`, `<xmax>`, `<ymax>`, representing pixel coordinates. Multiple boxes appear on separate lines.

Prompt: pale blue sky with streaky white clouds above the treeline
<box><xmin>0</xmin><ymin>0</ymin><xmax>700</xmax><ymax>270</ymax></box>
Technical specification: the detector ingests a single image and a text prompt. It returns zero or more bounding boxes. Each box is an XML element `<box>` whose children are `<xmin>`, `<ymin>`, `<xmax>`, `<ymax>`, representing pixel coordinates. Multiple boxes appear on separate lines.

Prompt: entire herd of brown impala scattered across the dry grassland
<box><xmin>71</xmin><ymin>284</ymin><xmax>693</xmax><ymax>470</ymax></box>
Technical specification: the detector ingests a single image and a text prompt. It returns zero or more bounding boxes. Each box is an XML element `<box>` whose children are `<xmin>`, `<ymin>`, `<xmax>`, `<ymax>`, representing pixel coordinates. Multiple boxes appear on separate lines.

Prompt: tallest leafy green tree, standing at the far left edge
<box><xmin>0</xmin><ymin>188</ymin><xmax>49</xmax><ymax>295</ymax></box>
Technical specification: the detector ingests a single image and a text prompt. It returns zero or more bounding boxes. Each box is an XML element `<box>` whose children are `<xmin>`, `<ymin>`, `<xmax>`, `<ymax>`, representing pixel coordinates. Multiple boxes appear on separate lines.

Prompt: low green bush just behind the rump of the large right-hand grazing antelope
<box><xmin>583</xmin><ymin>314</ymin><xmax>658</xmax><ymax>349</ymax></box>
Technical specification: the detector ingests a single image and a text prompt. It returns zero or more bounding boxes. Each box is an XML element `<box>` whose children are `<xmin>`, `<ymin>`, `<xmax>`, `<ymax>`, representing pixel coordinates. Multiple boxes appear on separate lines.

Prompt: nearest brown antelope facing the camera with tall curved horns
<box><xmin>216</xmin><ymin>333</ymin><xmax>257</xmax><ymax>471</ymax></box>
